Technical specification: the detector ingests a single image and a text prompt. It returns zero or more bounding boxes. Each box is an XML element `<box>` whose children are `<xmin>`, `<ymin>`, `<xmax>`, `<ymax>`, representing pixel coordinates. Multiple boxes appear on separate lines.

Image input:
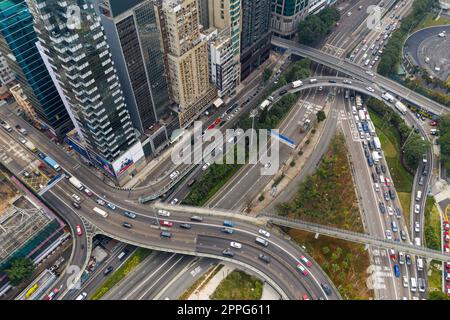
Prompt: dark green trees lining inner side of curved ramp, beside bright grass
<box><xmin>367</xmin><ymin>98</ymin><xmax>429</xmax><ymax>171</ymax></box>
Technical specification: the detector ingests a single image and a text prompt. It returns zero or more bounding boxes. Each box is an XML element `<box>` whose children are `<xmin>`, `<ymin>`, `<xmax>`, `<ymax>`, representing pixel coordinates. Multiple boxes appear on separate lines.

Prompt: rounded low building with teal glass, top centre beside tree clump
<box><xmin>270</xmin><ymin>0</ymin><xmax>310</xmax><ymax>38</ymax></box>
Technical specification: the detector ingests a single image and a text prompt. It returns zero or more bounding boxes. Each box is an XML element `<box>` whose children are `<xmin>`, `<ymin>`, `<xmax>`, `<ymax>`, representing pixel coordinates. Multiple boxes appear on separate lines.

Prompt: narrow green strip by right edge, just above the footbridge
<box><xmin>424</xmin><ymin>197</ymin><xmax>441</xmax><ymax>251</ymax></box>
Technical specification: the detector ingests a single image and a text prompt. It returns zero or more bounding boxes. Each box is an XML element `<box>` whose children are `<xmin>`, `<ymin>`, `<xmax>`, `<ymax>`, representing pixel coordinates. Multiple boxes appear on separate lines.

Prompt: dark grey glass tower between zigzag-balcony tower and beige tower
<box><xmin>99</xmin><ymin>0</ymin><xmax>170</xmax><ymax>132</ymax></box>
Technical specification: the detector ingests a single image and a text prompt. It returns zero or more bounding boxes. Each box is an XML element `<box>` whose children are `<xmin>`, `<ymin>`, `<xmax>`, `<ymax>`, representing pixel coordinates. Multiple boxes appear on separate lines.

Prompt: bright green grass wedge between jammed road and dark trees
<box><xmin>369</xmin><ymin>111</ymin><xmax>414</xmax><ymax>194</ymax></box>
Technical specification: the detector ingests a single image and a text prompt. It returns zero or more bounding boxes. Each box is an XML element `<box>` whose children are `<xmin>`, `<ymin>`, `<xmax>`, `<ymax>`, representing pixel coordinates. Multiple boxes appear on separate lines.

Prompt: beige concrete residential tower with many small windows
<box><xmin>155</xmin><ymin>0</ymin><xmax>217</xmax><ymax>127</ymax></box>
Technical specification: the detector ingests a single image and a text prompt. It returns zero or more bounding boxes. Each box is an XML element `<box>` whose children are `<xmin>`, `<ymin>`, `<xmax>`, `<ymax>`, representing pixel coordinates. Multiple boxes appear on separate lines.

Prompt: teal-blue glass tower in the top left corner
<box><xmin>0</xmin><ymin>0</ymin><xmax>73</xmax><ymax>138</ymax></box>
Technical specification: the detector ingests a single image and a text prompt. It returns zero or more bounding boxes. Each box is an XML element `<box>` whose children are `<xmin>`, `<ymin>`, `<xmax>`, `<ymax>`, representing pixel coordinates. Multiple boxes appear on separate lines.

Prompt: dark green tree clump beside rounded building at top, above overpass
<box><xmin>298</xmin><ymin>7</ymin><xmax>341</xmax><ymax>46</ymax></box>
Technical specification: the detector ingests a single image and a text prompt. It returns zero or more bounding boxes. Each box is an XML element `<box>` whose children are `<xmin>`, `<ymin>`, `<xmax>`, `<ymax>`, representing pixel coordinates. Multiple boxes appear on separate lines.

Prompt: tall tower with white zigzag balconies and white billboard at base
<box><xmin>27</xmin><ymin>0</ymin><xmax>145</xmax><ymax>182</ymax></box>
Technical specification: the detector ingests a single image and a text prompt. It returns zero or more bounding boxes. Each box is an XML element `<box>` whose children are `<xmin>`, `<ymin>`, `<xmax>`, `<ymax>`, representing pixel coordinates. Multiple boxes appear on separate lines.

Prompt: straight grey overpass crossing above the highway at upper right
<box><xmin>272</xmin><ymin>37</ymin><xmax>449</xmax><ymax>115</ymax></box>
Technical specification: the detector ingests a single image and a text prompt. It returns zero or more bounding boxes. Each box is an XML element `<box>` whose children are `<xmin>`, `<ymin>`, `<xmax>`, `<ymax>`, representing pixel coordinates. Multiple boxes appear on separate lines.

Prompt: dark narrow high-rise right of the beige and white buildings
<box><xmin>241</xmin><ymin>0</ymin><xmax>272</xmax><ymax>80</ymax></box>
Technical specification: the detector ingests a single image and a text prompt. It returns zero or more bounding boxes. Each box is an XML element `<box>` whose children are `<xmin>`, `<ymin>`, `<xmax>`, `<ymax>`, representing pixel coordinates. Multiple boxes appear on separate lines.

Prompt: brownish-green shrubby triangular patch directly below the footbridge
<box><xmin>289</xmin><ymin>229</ymin><xmax>374</xmax><ymax>300</ymax></box>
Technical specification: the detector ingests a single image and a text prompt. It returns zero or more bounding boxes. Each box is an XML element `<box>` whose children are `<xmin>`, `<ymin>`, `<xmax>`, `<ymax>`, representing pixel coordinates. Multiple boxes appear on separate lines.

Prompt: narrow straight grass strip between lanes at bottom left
<box><xmin>90</xmin><ymin>248</ymin><xmax>151</xmax><ymax>300</ymax></box>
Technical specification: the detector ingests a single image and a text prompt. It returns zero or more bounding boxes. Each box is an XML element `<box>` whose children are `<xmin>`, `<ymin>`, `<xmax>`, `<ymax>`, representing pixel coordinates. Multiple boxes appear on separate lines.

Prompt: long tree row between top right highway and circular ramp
<box><xmin>377</xmin><ymin>0</ymin><xmax>436</xmax><ymax>76</ymax></box>
